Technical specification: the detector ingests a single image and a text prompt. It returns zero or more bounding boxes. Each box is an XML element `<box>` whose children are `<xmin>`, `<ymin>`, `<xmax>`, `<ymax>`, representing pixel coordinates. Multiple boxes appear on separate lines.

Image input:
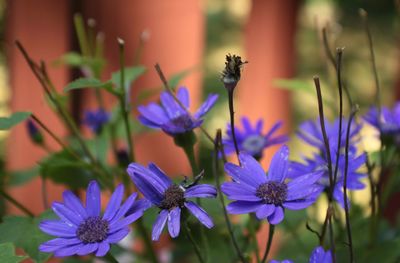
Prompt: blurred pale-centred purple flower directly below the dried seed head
<box><xmin>223</xmin><ymin>117</ymin><xmax>288</xmax><ymax>159</ymax></box>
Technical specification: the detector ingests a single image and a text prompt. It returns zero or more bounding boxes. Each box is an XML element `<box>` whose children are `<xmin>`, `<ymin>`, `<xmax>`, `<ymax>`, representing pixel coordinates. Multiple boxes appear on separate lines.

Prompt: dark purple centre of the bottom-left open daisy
<box><xmin>76</xmin><ymin>216</ymin><xmax>109</xmax><ymax>244</ymax></box>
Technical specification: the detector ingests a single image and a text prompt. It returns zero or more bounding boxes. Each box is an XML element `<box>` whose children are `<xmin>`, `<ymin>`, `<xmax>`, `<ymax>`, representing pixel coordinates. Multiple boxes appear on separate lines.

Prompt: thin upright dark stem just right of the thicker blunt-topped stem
<box><xmin>327</xmin><ymin>48</ymin><xmax>343</xmax><ymax>188</ymax></box>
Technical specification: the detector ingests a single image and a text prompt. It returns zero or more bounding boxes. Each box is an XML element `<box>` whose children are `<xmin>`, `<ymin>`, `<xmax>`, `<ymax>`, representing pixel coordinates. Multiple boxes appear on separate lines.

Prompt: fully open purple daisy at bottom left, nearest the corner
<box><xmin>39</xmin><ymin>181</ymin><xmax>143</xmax><ymax>257</ymax></box>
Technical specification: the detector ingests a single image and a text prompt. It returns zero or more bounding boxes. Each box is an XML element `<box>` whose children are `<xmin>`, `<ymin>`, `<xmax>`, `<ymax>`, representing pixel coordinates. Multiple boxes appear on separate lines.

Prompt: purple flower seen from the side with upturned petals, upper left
<box><xmin>138</xmin><ymin>87</ymin><xmax>218</xmax><ymax>136</ymax></box>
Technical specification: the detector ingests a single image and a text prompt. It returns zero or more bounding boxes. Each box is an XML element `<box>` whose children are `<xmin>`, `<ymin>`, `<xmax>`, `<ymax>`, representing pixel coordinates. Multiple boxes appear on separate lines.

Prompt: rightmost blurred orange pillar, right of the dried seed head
<box><xmin>236</xmin><ymin>0</ymin><xmax>298</xmax><ymax>260</ymax></box>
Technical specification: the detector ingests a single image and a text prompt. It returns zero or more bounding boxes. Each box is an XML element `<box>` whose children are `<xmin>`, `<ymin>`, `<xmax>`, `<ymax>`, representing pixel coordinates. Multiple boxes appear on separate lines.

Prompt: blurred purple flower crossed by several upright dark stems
<box><xmin>289</xmin><ymin>120</ymin><xmax>366</xmax><ymax>207</ymax></box>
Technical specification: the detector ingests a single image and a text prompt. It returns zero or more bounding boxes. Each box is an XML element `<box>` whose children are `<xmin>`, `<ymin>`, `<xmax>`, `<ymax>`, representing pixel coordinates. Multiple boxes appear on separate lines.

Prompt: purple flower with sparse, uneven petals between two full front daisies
<box><xmin>127</xmin><ymin>163</ymin><xmax>217</xmax><ymax>241</ymax></box>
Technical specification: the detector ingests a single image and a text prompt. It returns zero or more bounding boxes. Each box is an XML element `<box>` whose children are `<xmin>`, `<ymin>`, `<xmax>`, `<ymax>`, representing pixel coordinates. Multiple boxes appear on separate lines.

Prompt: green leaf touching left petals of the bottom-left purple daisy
<box><xmin>0</xmin><ymin>211</ymin><xmax>55</xmax><ymax>262</ymax></box>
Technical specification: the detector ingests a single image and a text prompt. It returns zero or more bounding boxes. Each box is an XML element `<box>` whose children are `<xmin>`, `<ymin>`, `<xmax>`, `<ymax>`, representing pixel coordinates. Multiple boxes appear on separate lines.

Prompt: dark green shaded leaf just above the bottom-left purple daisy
<box><xmin>40</xmin><ymin>151</ymin><xmax>94</xmax><ymax>190</ymax></box>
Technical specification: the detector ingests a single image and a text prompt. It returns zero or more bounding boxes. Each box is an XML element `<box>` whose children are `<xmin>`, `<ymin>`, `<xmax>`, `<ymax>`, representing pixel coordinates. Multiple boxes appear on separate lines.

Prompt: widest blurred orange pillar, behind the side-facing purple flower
<box><xmin>84</xmin><ymin>0</ymin><xmax>205</xmax><ymax>177</ymax></box>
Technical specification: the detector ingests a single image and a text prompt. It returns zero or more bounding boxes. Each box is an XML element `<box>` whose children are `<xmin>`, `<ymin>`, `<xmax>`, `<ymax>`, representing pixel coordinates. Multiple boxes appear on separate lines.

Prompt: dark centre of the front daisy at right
<box><xmin>256</xmin><ymin>181</ymin><xmax>287</xmax><ymax>205</ymax></box>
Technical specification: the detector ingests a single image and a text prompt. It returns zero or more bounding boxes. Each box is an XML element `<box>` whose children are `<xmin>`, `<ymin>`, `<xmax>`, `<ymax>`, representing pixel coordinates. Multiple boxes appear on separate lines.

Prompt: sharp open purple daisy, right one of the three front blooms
<box><xmin>221</xmin><ymin>145</ymin><xmax>321</xmax><ymax>225</ymax></box>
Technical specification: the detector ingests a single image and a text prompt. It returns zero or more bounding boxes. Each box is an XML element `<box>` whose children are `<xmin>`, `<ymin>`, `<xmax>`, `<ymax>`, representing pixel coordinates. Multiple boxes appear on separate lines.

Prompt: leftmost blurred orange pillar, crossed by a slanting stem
<box><xmin>6</xmin><ymin>0</ymin><xmax>71</xmax><ymax>213</ymax></box>
